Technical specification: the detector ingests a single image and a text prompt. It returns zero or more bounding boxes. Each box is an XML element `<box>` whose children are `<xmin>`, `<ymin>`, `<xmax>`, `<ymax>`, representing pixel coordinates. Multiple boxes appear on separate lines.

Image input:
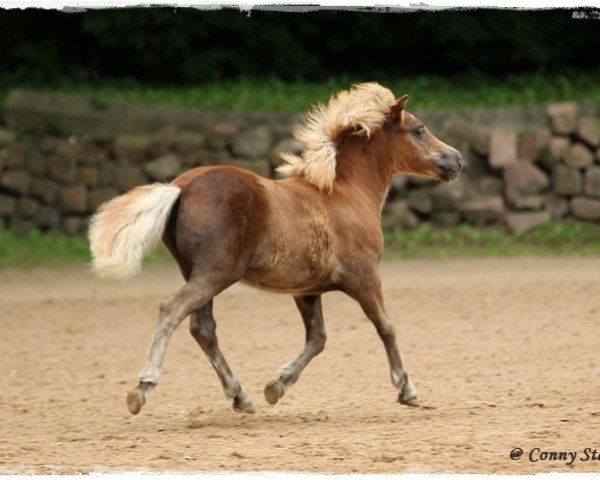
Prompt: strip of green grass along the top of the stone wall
<box><xmin>0</xmin><ymin>71</ymin><xmax>600</xmax><ymax>112</ymax></box>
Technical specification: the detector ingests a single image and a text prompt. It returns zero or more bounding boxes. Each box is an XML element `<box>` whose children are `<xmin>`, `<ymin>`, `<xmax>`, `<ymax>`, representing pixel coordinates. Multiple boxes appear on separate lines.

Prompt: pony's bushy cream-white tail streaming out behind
<box><xmin>88</xmin><ymin>183</ymin><xmax>181</xmax><ymax>279</ymax></box>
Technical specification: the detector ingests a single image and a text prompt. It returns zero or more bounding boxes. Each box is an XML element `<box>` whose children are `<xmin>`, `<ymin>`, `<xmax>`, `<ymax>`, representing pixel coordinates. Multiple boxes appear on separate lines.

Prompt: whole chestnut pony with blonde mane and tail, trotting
<box><xmin>89</xmin><ymin>83</ymin><xmax>463</xmax><ymax>414</ymax></box>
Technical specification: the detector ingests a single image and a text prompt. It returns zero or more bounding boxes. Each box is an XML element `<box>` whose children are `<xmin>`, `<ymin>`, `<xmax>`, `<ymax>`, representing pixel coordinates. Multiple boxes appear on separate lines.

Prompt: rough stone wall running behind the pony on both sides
<box><xmin>0</xmin><ymin>91</ymin><xmax>600</xmax><ymax>234</ymax></box>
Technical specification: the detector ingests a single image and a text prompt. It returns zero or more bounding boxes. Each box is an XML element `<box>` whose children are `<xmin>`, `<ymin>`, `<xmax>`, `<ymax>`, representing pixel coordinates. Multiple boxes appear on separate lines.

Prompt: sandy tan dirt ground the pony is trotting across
<box><xmin>0</xmin><ymin>257</ymin><xmax>600</xmax><ymax>474</ymax></box>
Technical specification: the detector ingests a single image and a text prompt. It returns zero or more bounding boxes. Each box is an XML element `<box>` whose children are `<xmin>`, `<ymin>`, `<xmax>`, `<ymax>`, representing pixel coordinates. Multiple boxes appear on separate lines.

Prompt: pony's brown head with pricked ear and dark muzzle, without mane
<box><xmin>382</xmin><ymin>95</ymin><xmax>464</xmax><ymax>182</ymax></box>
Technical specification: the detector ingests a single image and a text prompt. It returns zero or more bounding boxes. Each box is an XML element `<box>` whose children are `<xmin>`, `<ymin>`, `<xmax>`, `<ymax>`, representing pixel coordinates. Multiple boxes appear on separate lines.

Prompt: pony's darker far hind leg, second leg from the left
<box><xmin>190</xmin><ymin>300</ymin><xmax>254</xmax><ymax>413</ymax></box>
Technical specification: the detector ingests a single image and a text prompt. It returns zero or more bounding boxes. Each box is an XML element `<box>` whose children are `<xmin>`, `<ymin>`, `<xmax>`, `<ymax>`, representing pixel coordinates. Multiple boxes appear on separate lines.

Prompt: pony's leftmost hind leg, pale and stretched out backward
<box><xmin>127</xmin><ymin>281</ymin><xmax>218</xmax><ymax>415</ymax></box>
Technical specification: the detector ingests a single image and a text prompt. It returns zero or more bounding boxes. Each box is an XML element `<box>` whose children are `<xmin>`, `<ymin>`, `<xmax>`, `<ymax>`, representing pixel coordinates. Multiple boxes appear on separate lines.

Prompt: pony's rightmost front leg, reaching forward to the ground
<box><xmin>346</xmin><ymin>273</ymin><xmax>420</xmax><ymax>407</ymax></box>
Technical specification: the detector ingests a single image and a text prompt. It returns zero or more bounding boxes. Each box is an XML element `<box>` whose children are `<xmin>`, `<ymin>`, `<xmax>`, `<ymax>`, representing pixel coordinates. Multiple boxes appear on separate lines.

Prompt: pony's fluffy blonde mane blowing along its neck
<box><xmin>277</xmin><ymin>82</ymin><xmax>395</xmax><ymax>190</ymax></box>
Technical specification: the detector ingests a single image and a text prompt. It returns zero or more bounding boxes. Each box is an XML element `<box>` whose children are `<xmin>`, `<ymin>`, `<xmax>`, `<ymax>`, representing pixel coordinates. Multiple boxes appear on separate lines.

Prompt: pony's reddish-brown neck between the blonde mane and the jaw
<box><xmin>334</xmin><ymin>132</ymin><xmax>394</xmax><ymax>215</ymax></box>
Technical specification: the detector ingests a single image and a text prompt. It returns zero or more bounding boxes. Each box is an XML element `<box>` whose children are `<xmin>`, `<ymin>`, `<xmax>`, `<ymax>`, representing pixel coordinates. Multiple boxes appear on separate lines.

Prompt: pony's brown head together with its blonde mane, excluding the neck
<box><xmin>277</xmin><ymin>82</ymin><xmax>463</xmax><ymax>191</ymax></box>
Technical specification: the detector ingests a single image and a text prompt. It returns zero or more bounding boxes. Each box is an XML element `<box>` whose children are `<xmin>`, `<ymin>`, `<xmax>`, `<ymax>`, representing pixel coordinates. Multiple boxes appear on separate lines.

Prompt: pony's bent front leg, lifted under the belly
<box><xmin>264</xmin><ymin>295</ymin><xmax>327</xmax><ymax>405</ymax></box>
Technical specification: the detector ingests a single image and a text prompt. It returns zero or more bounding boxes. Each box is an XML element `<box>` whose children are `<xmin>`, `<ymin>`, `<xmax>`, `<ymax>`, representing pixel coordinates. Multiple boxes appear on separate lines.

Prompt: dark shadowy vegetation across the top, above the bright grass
<box><xmin>0</xmin><ymin>10</ymin><xmax>598</xmax><ymax>85</ymax></box>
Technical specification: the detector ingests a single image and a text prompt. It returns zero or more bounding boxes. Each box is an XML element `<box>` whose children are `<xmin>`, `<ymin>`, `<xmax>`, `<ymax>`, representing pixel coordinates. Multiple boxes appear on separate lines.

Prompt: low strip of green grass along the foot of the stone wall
<box><xmin>0</xmin><ymin>222</ymin><xmax>600</xmax><ymax>268</ymax></box>
